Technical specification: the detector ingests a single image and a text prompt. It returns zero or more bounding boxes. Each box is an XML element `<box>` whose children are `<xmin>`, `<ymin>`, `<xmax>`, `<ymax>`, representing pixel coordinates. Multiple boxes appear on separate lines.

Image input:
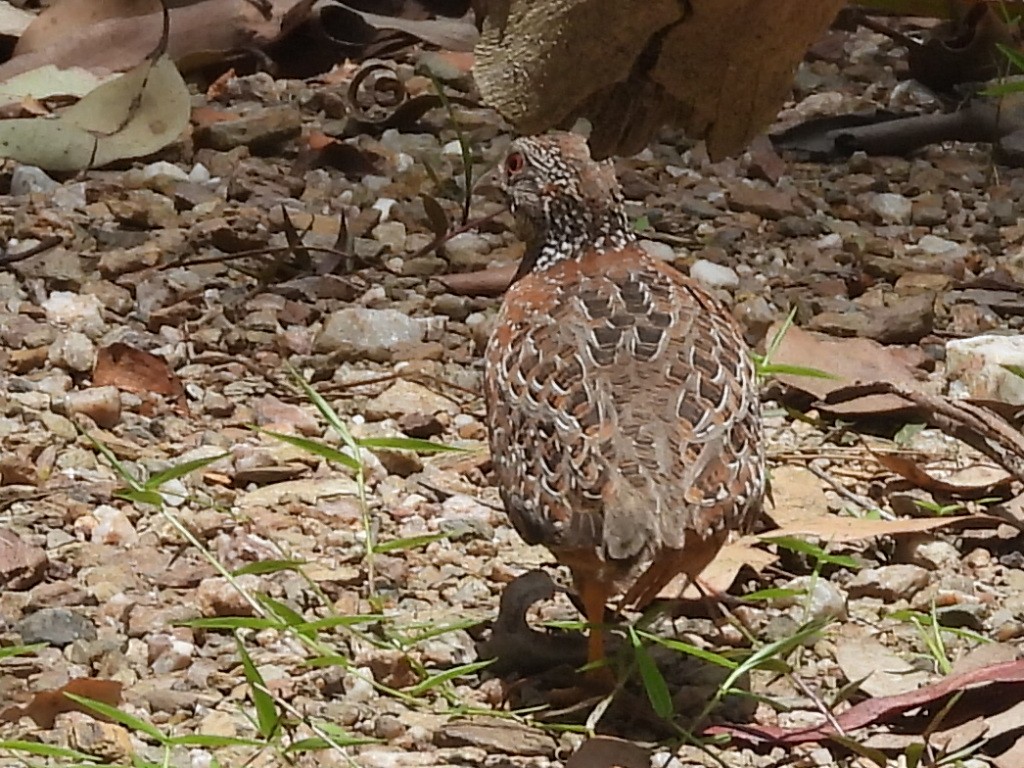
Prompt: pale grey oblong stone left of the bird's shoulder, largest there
<box><xmin>313</xmin><ymin>307</ymin><xmax>427</xmax><ymax>362</ymax></box>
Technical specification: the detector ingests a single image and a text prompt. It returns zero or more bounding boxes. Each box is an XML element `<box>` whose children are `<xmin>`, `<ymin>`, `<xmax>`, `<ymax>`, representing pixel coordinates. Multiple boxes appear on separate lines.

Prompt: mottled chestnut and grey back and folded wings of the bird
<box><xmin>486</xmin><ymin>249</ymin><xmax>764</xmax><ymax>560</ymax></box>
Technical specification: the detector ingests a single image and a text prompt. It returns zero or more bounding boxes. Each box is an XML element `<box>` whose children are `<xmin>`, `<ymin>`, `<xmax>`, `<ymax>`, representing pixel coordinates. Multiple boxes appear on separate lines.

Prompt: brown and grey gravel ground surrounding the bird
<box><xmin>0</xmin><ymin>24</ymin><xmax>1024</xmax><ymax>768</ymax></box>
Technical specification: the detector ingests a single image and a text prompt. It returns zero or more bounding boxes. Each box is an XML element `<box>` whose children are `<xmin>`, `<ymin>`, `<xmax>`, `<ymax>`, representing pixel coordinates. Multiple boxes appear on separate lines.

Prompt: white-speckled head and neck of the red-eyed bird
<box><xmin>502</xmin><ymin>133</ymin><xmax>632</xmax><ymax>273</ymax></box>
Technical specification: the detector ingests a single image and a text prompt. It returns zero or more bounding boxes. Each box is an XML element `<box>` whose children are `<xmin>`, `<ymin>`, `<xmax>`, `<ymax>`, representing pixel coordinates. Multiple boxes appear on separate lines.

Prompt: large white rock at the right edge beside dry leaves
<box><xmin>946</xmin><ymin>334</ymin><xmax>1024</xmax><ymax>406</ymax></box>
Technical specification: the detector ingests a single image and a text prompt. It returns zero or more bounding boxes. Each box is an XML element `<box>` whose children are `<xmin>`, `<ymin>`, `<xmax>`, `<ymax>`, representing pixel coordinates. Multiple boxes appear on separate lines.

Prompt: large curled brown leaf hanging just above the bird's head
<box><xmin>474</xmin><ymin>0</ymin><xmax>845</xmax><ymax>159</ymax></box>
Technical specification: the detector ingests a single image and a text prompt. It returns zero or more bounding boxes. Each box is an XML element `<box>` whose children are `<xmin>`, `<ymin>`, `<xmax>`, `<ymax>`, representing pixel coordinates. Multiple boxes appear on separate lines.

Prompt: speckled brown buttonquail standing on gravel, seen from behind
<box><xmin>484</xmin><ymin>133</ymin><xmax>765</xmax><ymax>675</ymax></box>
